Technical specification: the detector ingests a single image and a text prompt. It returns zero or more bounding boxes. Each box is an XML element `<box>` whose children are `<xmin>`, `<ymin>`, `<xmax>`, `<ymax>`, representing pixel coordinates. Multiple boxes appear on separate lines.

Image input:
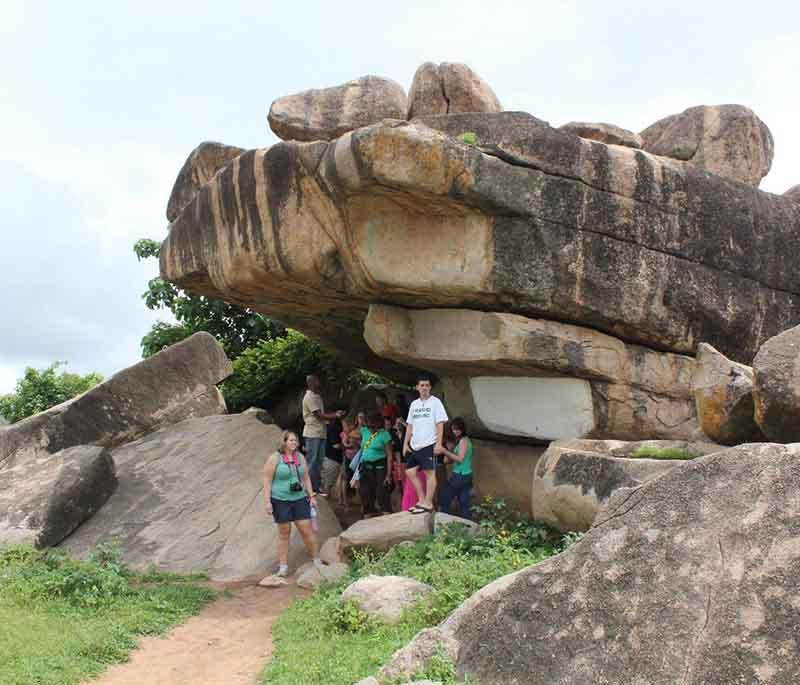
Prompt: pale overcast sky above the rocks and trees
<box><xmin>0</xmin><ymin>0</ymin><xmax>800</xmax><ymax>393</ymax></box>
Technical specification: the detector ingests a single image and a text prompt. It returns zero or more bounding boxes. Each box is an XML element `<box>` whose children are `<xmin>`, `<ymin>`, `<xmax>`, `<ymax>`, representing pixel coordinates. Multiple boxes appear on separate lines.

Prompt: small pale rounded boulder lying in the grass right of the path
<box><xmin>342</xmin><ymin>575</ymin><xmax>433</xmax><ymax>623</ymax></box>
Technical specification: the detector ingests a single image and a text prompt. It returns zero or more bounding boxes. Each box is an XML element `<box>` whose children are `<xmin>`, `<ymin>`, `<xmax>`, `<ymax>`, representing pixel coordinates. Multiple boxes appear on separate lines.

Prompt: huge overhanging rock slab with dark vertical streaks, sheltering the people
<box><xmin>161</xmin><ymin>112</ymin><xmax>800</xmax><ymax>372</ymax></box>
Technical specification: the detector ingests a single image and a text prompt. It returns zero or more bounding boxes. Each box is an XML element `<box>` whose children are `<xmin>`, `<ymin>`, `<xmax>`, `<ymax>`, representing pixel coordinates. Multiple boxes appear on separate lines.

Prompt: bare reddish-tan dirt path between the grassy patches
<box><xmin>86</xmin><ymin>584</ymin><xmax>304</xmax><ymax>685</ymax></box>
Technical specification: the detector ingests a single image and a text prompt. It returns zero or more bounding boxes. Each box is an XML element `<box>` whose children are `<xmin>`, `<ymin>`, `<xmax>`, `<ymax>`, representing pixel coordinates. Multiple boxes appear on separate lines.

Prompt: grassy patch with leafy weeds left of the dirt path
<box><xmin>0</xmin><ymin>545</ymin><xmax>216</xmax><ymax>685</ymax></box>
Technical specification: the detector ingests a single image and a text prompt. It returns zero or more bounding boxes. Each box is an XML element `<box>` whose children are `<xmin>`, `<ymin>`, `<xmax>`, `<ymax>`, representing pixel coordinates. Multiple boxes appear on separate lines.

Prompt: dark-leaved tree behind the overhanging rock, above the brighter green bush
<box><xmin>133</xmin><ymin>239</ymin><xmax>284</xmax><ymax>359</ymax></box>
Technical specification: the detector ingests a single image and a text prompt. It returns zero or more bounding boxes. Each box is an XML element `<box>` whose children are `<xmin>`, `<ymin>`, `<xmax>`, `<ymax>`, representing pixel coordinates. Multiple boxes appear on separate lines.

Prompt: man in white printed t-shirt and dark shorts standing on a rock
<box><xmin>403</xmin><ymin>376</ymin><xmax>447</xmax><ymax>514</ymax></box>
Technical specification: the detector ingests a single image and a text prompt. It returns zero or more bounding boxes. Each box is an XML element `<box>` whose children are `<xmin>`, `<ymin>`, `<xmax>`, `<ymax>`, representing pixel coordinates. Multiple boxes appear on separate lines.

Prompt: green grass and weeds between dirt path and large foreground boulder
<box><xmin>262</xmin><ymin>501</ymin><xmax>573</xmax><ymax>685</ymax></box>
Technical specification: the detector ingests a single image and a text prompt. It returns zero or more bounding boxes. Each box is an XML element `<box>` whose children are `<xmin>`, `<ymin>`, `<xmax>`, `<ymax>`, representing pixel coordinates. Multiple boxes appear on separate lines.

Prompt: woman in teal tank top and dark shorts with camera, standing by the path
<box><xmin>264</xmin><ymin>431</ymin><xmax>320</xmax><ymax>577</ymax></box>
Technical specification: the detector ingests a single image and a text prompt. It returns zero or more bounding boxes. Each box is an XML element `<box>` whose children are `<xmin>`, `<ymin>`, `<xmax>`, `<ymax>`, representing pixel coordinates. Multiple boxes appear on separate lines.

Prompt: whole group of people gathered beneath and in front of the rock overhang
<box><xmin>264</xmin><ymin>375</ymin><xmax>473</xmax><ymax>576</ymax></box>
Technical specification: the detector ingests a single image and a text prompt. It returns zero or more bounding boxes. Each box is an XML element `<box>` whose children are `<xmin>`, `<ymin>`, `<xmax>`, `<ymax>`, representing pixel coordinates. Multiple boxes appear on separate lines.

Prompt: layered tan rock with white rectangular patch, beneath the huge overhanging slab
<box><xmin>372</xmin><ymin>305</ymin><xmax>698</xmax><ymax>441</ymax></box>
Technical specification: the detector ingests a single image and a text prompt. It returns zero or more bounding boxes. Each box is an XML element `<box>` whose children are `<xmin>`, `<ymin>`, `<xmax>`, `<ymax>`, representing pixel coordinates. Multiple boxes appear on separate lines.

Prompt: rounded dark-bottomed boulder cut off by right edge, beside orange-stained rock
<box><xmin>753</xmin><ymin>326</ymin><xmax>800</xmax><ymax>442</ymax></box>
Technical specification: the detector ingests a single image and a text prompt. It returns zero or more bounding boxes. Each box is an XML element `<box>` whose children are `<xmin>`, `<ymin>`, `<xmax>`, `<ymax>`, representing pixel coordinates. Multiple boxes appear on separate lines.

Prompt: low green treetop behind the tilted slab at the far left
<box><xmin>0</xmin><ymin>362</ymin><xmax>103</xmax><ymax>423</ymax></box>
